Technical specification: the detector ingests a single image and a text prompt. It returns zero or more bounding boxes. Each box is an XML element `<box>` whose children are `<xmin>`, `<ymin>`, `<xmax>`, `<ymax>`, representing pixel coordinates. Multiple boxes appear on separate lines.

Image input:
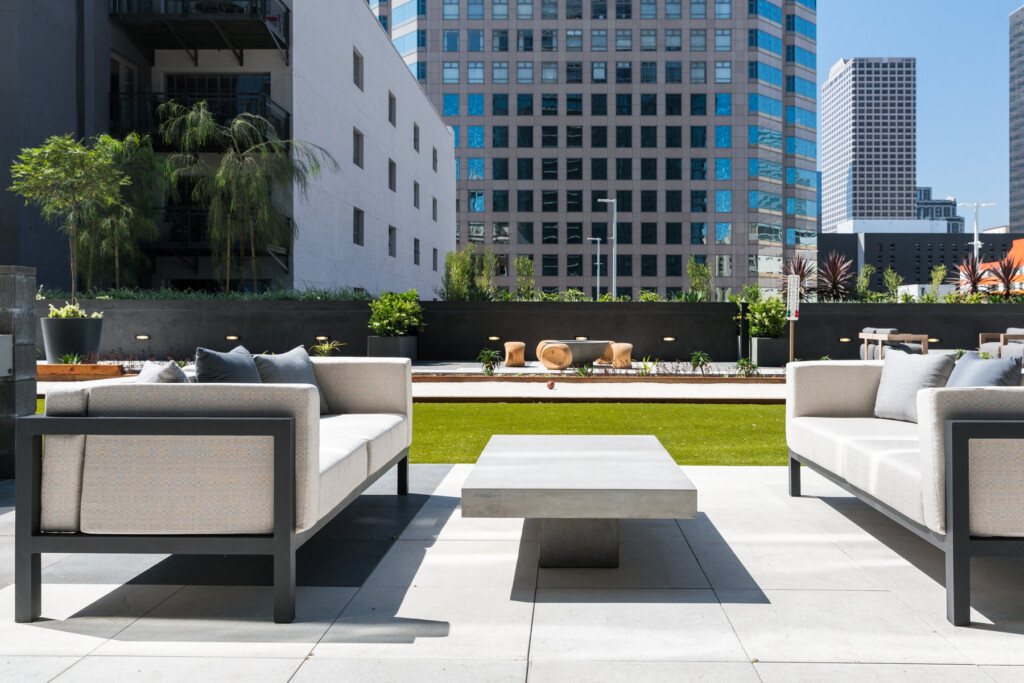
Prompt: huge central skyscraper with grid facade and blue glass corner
<box><xmin>380</xmin><ymin>0</ymin><xmax>818</xmax><ymax>297</ymax></box>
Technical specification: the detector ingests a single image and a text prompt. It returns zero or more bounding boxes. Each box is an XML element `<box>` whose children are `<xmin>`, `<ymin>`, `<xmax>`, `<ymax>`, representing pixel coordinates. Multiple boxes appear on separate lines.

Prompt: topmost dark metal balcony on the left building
<box><xmin>110</xmin><ymin>0</ymin><xmax>292</xmax><ymax>63</ymax></box>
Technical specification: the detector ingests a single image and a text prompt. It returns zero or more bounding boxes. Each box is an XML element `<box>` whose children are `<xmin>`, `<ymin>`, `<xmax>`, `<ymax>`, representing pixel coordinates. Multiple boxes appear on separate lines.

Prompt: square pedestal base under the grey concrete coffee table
<box><xmin>540</xmin><ymin>519</ymin><xmax>618</xmax><ymax>568</ymax></box>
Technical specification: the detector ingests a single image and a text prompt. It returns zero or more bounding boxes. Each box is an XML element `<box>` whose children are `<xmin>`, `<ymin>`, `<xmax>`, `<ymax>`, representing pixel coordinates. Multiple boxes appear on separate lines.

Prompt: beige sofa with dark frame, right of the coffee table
<box><xmin>785</xmin><ymin>361</ymin><xmax>1024</xmax><ymax>626</ymax></box>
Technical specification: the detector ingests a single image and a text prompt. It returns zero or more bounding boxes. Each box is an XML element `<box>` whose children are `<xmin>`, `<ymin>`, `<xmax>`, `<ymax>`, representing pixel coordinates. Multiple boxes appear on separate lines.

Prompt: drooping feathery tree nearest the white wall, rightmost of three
<box><xmin>159</xmin><ymin>100</ymin><xmax>340</xmax><ymax>292</ymax></box>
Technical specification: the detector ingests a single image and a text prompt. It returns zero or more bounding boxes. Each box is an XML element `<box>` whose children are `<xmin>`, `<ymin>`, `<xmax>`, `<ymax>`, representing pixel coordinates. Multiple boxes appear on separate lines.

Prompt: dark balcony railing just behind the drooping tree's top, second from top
<box><xmin>111</xmin><ymin>92</ymin><xmax>291</xmax><ymax>142</ymax></box>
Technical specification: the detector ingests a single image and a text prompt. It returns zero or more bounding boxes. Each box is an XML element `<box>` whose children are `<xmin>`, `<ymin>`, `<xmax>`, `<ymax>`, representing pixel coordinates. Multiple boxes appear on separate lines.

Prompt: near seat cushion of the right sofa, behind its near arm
<box><xmin>844</xmin><ymin>438</ymin><xmax>925</xmax><ymax>524</ymax></box>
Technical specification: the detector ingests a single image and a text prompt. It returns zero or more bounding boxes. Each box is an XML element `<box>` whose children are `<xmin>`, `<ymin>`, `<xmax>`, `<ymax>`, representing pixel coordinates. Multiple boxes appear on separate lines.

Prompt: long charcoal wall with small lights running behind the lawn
<box><xmin>29</xmin><ymin>300</ymin><xmax>1024</xmax><ymax>362</ymax></box>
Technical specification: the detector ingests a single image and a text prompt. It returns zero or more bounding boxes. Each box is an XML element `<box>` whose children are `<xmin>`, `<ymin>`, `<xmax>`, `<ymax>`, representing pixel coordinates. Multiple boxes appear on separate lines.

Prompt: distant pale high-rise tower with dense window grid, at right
<box><xmin>821</xmin><ymin>57</ymin><xmax>918</xmax><ymax>232</ymax></box>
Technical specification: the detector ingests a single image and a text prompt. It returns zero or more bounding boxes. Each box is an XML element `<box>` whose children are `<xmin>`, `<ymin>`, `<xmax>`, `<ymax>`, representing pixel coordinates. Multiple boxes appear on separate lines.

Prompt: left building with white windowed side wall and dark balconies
<box><xmin>0</xmin><ymin>0</ymin><xmax>455</xmax><ymax>297</ymax></box>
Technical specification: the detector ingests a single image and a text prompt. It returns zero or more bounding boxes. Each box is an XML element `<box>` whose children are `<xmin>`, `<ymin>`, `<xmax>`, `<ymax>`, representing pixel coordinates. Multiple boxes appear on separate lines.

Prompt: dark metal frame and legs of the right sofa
<box><xmin>790</xmin><ymin>420</ymin><xmax>1024</xmax><ymax>626</ymax></box>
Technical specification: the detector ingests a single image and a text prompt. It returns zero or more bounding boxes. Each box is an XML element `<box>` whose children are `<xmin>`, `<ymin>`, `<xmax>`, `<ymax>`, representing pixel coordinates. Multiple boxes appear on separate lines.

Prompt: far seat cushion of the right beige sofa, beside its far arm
<box><xmin>785</xmin><ymin>418</ymin><xmax>918</xmax><ymax>476</ymax></box>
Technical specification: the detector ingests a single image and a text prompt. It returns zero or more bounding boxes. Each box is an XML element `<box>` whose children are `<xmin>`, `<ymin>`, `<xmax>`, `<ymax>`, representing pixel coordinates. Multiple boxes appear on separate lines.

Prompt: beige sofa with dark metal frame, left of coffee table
<box><xmin>15</xmin><ymin>358</ymin><xmax>413</xmax><ymax>622</ymax></box>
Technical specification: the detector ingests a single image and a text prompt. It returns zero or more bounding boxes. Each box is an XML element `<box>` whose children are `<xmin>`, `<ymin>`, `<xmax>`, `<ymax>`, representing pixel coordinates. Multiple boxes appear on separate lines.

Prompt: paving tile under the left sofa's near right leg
<box><xmin>93</xmin><ymin>586</ymin><xmax>355</xmax><ymax>658</ymax></box>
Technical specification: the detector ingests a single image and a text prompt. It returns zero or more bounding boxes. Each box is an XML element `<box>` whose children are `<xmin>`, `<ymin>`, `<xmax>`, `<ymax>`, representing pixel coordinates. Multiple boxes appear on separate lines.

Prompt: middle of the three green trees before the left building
<box><xmin>89</xmin><ymin>133</ymin><xmax>174</xmax><ymax>289</ymax></box>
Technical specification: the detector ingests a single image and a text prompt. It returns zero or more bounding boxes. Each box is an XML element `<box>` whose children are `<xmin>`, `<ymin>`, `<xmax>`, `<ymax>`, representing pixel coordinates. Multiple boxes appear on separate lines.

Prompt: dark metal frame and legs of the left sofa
<box><xmin>14</xmin><ymin>415</ymin><xmax>409</xmax><ymax>624</ymax></box>
